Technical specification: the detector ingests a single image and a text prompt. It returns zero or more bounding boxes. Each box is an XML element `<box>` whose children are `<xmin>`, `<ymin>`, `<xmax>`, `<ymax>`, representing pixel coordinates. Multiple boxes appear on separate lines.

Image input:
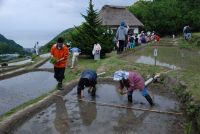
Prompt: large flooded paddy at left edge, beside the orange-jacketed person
<box><xmin>0</xmin><ymin>72</ymin><xmax>57</xmax><ymax>115</ymax></box>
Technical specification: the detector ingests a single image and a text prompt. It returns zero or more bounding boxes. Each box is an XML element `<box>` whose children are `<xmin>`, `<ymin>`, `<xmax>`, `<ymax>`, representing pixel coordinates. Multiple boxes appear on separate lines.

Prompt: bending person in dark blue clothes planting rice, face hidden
<box><xmin>77</xmin><ymin>70</ymin><xmax>97</xmax><ymax>97</ymax></box>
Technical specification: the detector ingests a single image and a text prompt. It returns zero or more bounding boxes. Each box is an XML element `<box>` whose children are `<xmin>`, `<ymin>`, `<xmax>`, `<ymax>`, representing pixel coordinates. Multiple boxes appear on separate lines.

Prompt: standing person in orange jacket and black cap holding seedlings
<box><xmin>51</xmin><ymin>37</ymin><xmax>68</xmax><ymax>90</ymax></box>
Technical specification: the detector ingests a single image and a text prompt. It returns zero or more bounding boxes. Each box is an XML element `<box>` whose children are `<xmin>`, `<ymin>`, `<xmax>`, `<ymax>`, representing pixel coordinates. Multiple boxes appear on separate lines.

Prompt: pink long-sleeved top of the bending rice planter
<box><xmin>119</xmin><ymin>72</ymin><xmax>145</xmax><ymax>91</ymax></box>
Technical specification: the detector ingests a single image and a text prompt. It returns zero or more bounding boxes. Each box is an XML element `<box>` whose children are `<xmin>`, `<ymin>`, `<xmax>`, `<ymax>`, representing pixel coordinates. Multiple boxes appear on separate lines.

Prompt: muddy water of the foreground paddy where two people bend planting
<box><xmin>14</xmin><ymin>83</ymin><xmax>182</xmax><ymax>134</ymax></box>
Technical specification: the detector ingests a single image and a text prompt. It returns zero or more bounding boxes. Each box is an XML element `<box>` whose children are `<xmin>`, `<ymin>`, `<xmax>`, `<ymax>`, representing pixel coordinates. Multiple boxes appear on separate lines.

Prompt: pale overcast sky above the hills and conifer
<box><xmin>0</xmin><ymin>0</ymin><xmax>137</xmax><ymax>48</ymax></box>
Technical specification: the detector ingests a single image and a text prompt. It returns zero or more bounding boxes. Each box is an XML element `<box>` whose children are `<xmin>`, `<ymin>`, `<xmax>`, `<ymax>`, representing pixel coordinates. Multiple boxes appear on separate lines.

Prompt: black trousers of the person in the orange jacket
<box><xmin>54</xmin><ymin>67</ymin><xmax>65</xmax><ymax>82</ymax></box>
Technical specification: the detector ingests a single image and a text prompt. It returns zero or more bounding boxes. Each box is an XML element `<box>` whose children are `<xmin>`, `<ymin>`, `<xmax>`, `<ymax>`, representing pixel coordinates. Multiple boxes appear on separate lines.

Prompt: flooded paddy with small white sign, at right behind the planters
<box><xmin>123</xmin><ymin>47</ymin><xmax>200</xmax><ymax>71</ymax></box>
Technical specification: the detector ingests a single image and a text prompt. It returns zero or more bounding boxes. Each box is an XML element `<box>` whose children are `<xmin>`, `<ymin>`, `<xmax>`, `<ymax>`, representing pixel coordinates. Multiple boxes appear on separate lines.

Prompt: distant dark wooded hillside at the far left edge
<box><xmin>0</xmin><ymin>34</ymin><xmax>25</xmax><ymax>55</ymax></box>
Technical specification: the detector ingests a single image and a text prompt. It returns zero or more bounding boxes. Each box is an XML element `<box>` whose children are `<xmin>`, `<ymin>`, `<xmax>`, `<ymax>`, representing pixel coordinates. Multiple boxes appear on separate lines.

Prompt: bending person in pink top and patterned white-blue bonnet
<box><xmin>113</xmin><ymin>71</ymin><xmax>155</xmax><ymax>106</ymax></box>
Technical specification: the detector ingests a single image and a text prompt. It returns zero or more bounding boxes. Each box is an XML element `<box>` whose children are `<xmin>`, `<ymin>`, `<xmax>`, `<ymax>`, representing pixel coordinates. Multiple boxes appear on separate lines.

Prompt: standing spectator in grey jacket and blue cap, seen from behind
<box><xmin>116</xmin><ymin>22</ymin><xmax>129</xmax><ymax>54</ymax></box>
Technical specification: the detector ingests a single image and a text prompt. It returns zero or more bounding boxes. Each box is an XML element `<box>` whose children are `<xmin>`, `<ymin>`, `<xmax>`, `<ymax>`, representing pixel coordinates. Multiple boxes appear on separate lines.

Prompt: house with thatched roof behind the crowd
<box><xmin>99</xmin><ymin>5</ymin><xmax>144</xmax><ymax>34</ymax></box>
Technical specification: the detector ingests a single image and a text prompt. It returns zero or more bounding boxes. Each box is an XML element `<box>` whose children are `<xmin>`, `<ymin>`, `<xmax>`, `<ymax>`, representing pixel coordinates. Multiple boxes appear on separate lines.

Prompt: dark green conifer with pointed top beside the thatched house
<box><xmin>69</xmin><ymin>0</ymin><xmax>114</xmax><ymax>55</ymax></box>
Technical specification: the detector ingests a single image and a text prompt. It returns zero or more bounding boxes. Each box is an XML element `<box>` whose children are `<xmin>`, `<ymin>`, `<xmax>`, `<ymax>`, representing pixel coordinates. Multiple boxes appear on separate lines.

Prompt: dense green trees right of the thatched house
<box><xmin>127</xmin><ymin>0</ymin><xmax>200</xmax><ymax>36</ymax></box>
